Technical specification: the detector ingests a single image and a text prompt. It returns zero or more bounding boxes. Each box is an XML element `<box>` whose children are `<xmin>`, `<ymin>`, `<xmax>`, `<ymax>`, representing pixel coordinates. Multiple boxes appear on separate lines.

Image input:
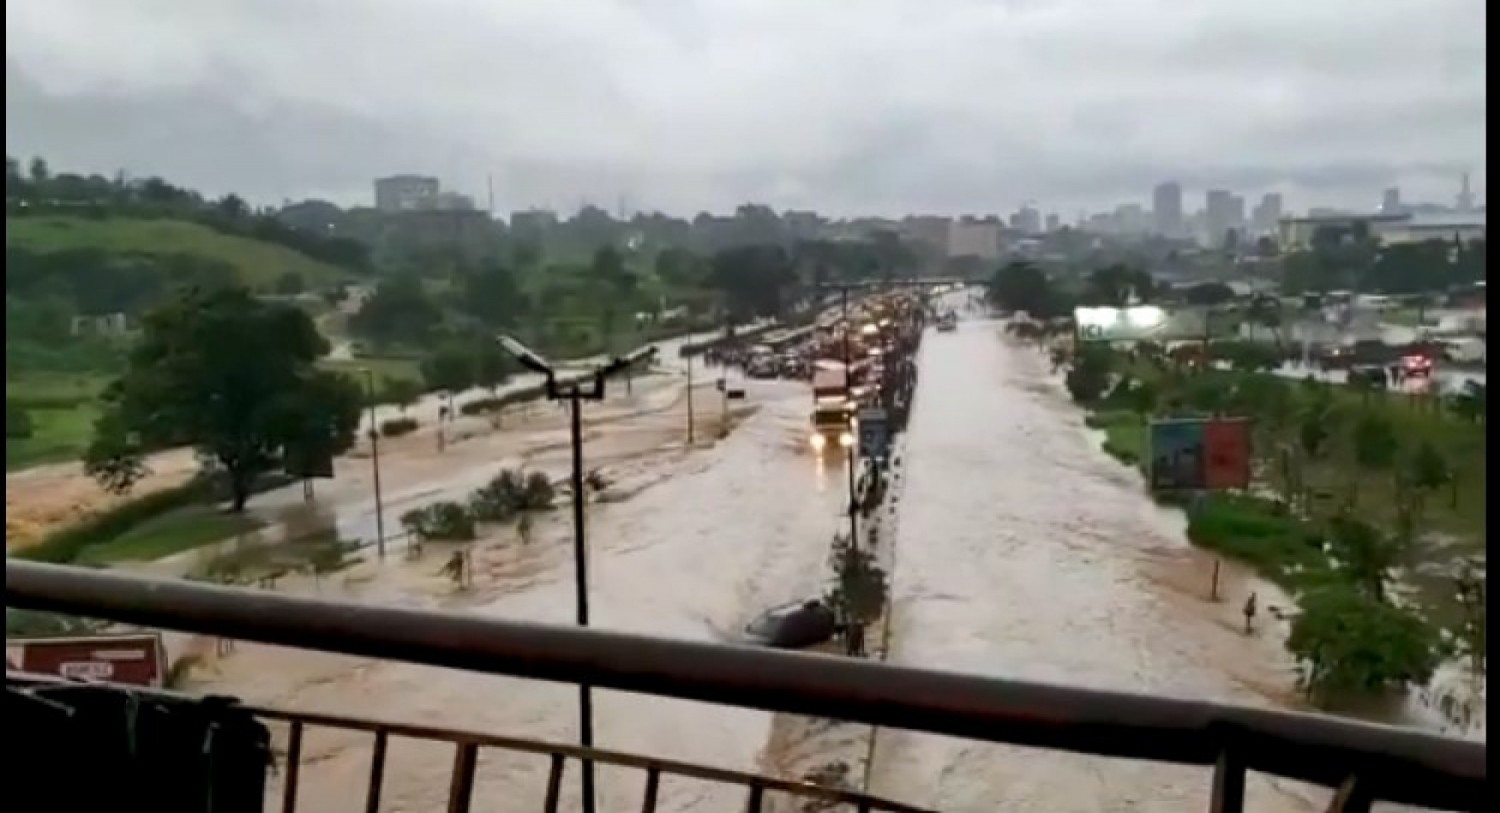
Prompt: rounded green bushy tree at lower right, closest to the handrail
<box><xmin>1287</xmin><ymin>584</ymin><xmax>1445</xmax><ymax>705</ymax></box>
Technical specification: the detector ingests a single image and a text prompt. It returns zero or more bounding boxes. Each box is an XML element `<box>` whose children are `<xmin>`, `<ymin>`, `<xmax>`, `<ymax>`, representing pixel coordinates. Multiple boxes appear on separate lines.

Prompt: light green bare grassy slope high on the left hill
<box><xmin>5</xmin><ymin>216</ymin><xmax>348</xmax><ymax>290</ymax></box>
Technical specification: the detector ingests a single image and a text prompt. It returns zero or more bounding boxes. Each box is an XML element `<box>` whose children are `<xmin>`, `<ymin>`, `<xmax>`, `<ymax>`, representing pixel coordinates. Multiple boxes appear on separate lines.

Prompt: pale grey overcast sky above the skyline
<box><xmin>6</xmin><ymin>0</ymin><xmax>1485</xmax><ymax>218</ymax></box>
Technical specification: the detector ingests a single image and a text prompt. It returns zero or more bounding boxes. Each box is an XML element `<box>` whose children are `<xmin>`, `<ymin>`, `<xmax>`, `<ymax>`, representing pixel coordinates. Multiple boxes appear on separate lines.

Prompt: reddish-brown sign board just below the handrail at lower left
<box><xmin>6</xmin><ymin>633</ymin><xmax>167</xmax><ymax>689</ymax></box>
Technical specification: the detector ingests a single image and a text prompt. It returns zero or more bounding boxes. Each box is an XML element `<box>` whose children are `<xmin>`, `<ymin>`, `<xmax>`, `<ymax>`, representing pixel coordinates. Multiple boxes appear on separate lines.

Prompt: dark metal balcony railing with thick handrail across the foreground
<box><xmin>6</xmin><ymin>560</ymin><xmax>1488</xmax><ymax>813</ymax></box>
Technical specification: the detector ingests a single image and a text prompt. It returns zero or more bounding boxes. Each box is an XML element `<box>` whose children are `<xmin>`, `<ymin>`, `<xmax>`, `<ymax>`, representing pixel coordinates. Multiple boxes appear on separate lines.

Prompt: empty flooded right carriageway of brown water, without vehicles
<box><xmin>870</xmin><ymin>321</ymin><xmax>1317</xmax><ymax>813</ymax></box>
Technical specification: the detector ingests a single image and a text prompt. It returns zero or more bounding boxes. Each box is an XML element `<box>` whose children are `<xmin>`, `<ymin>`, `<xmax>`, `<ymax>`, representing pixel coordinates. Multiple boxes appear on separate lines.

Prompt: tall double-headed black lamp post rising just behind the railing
<box><xmin>500</xmin><ymin>336</ymin><xmax>656</xmax><ymax>813</ymax></box>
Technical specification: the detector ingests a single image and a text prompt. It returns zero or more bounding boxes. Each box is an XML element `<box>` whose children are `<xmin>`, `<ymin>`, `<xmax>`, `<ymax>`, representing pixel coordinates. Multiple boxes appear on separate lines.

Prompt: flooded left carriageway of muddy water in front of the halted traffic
<box><xmin>193</xmin><ymin>377</ymin><xmax>843</xmax><ymax>812</ymax></box>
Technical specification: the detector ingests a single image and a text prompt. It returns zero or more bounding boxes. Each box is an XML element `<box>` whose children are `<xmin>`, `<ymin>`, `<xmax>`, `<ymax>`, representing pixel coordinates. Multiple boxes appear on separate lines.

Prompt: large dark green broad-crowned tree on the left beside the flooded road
<box><xmin>94</xmin><ymin>288</ymin><xmax>359</xmax><ymax>512</ymax></box>
